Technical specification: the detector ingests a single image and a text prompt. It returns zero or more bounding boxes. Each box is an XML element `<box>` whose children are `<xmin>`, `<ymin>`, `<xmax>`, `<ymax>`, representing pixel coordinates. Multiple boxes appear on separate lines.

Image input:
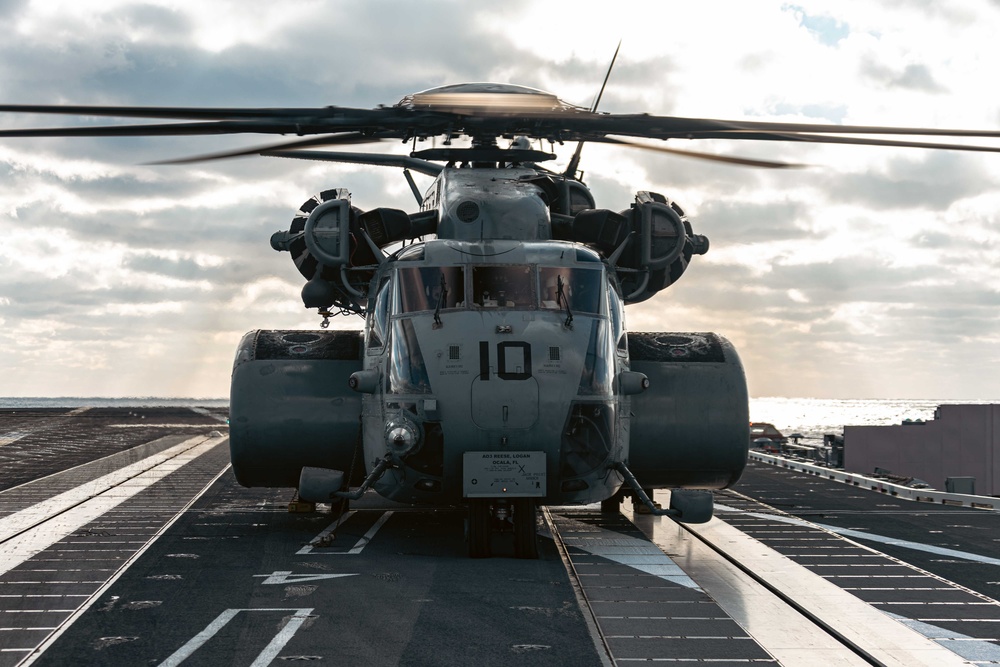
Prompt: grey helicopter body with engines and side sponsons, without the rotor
<box><xmin>230</xmin><ymin>163</ymin><xmax>749</xmax><ymax>557</ymax></box>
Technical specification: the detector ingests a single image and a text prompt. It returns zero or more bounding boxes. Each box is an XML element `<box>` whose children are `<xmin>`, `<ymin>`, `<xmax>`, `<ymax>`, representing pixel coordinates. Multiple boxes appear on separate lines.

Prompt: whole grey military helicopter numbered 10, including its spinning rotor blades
<box><xmin>0</xmin><ymin>80</ymin><xmax>1000</xmax><ymax>558</ymax></box>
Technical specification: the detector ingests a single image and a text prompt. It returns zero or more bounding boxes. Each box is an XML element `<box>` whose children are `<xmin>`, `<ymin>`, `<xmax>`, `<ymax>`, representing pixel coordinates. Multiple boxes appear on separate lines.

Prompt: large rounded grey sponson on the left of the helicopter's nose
<box><xmin>229</xmin><ymin>331</ymin><xmax>364</xmax><ymax>487</ymax></box>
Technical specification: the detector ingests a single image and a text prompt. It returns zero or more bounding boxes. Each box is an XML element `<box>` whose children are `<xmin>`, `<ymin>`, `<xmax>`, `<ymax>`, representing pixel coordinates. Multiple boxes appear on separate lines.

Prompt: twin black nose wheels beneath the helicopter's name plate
<box><xmin>468</xmin><ymin>498</ymin><xmax>538</xmax><ymax>559</ymax></box>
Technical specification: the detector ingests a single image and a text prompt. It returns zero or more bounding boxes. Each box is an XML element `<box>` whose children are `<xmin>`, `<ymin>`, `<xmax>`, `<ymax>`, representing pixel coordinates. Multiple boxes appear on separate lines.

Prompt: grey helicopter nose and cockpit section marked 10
<box><xmin>362</xmin><ymin>239</ymin><xmax>628</xmax><ymax>503</ymax></box>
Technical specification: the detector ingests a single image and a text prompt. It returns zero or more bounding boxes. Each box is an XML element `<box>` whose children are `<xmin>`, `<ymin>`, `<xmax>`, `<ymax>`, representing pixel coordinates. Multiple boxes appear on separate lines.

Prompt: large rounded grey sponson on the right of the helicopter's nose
<box><xmin>628</xmin><ymin>332</ymin><xmax>750</xmax><ymax>489</ymax></box>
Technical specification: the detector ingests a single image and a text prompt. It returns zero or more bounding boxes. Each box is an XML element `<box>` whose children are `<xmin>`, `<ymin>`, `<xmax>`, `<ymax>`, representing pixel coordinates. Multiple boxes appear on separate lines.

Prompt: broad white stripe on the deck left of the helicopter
<box><xmin>0</xmin><ymin>436</ymin><xmax>224</xmax><ymax>574</ymax></box>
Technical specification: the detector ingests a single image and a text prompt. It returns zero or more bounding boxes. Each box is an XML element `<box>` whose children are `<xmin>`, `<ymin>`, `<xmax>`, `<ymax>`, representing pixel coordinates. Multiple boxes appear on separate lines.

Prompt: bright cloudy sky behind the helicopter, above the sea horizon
<box><xmin>0</xmin><ymin>0</ymin><xmax>1000</xmax><ymax>399</ymax></box>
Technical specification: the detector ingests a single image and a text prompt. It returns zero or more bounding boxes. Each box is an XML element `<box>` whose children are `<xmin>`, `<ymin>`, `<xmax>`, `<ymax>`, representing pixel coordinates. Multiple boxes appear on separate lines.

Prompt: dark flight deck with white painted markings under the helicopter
<box><xmin>0</xmin><ymin>413</ymin><xmax>1000</xmax><ymax>667</ymax></box>
